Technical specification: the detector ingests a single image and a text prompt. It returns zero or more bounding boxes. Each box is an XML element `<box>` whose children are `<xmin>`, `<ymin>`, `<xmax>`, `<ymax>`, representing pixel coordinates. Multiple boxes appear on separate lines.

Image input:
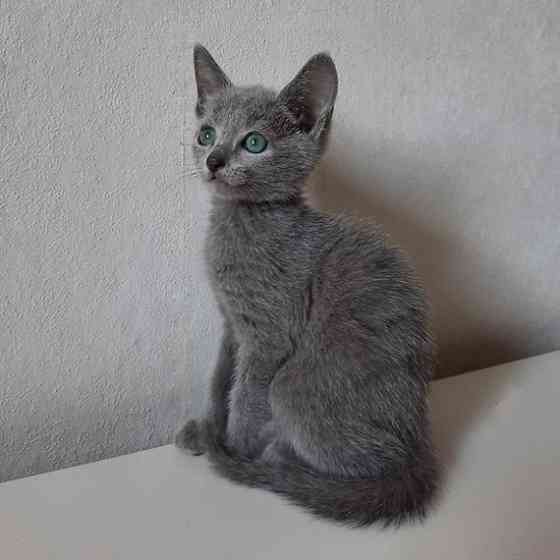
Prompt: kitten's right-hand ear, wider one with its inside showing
<box><xmin>277</xmin><ymin>53</ymin><xmax>338</xmax><ymax>148</ymax></box>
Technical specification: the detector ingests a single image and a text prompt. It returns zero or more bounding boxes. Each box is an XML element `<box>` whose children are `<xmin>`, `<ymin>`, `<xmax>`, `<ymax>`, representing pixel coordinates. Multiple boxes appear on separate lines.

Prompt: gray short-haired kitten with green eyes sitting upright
<box><xmin>177</xmin><ymin>45</ymin><xmax>437</xmax><ymax>525</ymax></box>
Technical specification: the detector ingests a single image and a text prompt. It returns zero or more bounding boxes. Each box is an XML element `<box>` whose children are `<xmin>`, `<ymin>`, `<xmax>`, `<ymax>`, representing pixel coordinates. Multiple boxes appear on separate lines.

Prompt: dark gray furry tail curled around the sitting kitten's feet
<box><xmin>203</xmin><ymin>427</ymin><xmax>437</xmax><ymax>527</ymax></box>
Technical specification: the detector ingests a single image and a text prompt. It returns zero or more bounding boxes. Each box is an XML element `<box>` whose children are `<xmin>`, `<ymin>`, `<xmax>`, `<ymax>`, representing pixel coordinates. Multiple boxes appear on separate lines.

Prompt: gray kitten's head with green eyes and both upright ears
<box><xmin>193</xmin><ymin>45</ymin><xmax>338</xmax><ymax>202</ymax></box>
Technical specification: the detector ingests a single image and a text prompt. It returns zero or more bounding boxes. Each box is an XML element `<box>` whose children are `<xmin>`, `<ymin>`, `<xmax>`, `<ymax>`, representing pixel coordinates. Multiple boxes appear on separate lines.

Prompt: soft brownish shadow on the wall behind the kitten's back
<box><xmin>309</xmin><ymin>132</ymin><xmax>530</xmax><ymax>377</ymax></box>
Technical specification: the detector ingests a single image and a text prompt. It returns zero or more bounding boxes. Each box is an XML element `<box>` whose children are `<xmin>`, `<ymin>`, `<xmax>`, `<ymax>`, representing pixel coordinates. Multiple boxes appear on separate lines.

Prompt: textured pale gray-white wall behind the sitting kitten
<box><xmin>0</xmin><ymin>0</ymin><xmax>560</xmax><ymax>480</ymax></box>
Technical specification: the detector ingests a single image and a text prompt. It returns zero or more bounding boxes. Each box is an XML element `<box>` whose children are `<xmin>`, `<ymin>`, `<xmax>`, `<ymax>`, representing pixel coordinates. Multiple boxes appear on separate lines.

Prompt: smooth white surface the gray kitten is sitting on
<box><xmin>0</xmin><ymin>352</ymin><xmax>560</xmax><ymax>560</ymax></box>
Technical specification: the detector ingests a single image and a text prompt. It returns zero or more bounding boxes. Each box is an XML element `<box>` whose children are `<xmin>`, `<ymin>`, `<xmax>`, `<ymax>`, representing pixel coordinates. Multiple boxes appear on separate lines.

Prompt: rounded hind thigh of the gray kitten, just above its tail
<box><xmin>270</xmin><ymin>351</ymin><xmax>402</xmax><ymax>478</ymax></box>
